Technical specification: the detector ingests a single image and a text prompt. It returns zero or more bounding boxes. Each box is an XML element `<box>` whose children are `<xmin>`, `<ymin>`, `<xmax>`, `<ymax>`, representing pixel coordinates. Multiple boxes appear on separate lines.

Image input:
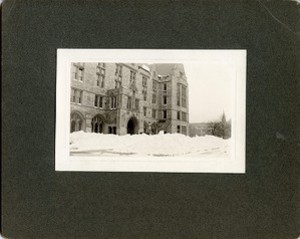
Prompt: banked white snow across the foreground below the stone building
<box><xmin>70</xmin><ymin>131</ymin><xmax>230</xmax><ymax>158</ymax></box>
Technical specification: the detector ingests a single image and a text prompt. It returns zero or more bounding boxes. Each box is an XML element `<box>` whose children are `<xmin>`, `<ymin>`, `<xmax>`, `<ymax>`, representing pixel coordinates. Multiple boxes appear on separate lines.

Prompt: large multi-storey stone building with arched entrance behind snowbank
<box><xmin>70</xmin><ymin>62</ymin><xmax>189</xmax><ymax>135</ymax></box>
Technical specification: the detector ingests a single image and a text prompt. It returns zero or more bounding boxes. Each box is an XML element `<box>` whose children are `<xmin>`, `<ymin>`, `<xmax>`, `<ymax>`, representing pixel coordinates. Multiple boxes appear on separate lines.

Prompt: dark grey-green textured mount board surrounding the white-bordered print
<box><xmin>1</xmin><ymin>0</ymin><xmax>299</xmax><ymax>239</ymax></box>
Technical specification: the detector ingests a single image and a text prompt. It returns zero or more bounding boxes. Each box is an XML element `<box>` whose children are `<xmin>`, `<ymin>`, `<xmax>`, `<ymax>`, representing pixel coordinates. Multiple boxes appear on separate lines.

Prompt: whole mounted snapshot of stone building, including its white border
<box><xmin>56</xmin><ymin>49</ymin><xmax>246</xmax><ymax>173</ymax></box>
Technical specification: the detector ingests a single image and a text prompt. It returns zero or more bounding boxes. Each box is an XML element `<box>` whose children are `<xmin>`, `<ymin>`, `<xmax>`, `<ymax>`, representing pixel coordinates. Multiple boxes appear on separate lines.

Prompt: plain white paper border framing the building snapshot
<box><xmin>55</xmin><ymin>49</ymin><xmax>247</xmax><ymax>173</ymax></box>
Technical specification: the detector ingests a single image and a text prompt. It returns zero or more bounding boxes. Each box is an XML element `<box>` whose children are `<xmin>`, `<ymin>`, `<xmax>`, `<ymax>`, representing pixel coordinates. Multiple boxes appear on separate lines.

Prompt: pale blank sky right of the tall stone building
<box><xmin>184</xmin><ymin>62</ymin><xmax>234</xmax><ymax>123</ymax></box>
